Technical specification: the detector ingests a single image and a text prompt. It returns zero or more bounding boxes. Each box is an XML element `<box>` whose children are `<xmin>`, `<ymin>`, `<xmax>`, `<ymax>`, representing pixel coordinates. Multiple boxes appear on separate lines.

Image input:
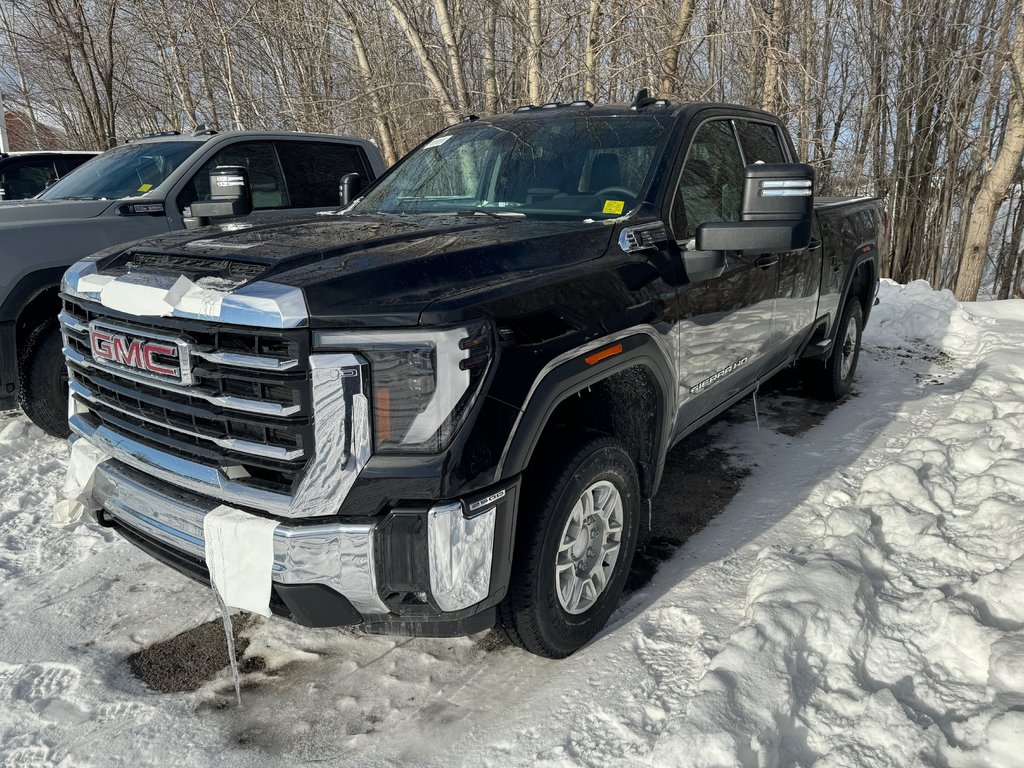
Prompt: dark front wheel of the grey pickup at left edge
<box><xmin>18</xmin><ymin>321</ymin><xmax>71</xmax><ymax>437</ymax></box>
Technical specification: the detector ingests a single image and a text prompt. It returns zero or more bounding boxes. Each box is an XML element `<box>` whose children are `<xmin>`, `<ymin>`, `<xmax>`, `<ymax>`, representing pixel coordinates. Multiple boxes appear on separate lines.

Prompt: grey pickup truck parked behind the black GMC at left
<box><xmin>0</xmin><ymin>129</ymin><xmax>385</xmax><ymax>436</ymax></box>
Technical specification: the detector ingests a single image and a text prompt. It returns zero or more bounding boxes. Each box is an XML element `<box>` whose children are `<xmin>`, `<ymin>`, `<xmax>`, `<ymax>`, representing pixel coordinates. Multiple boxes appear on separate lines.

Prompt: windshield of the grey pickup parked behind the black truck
<box><xmin>39</xmin><ymin>141</ymin><xmax>203</xmax><ymax>200</ymax></box>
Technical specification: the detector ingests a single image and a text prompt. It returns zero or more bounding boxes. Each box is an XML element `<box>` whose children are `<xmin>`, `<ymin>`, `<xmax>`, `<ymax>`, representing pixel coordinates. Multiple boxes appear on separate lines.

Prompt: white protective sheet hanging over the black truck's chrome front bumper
<box><xmin>203</xmin><ymin>505</ymin><xmax>278</xmax><ymax>616</ymax></box>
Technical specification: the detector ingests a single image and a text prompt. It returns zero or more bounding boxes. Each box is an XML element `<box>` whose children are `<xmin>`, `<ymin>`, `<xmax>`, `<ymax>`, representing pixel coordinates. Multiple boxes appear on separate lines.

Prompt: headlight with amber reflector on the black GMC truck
<box><xmin>313</xmin><ymin>324</ymin><xmax>490</xmax><ymax>454</ymax></box>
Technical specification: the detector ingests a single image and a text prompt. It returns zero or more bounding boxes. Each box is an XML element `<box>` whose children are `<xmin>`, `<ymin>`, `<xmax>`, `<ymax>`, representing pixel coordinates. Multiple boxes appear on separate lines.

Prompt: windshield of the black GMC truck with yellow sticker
<box><xmin>351</xmin><ymin>115</ymin><xmax>671</xmax><ymax>219</ymax></box>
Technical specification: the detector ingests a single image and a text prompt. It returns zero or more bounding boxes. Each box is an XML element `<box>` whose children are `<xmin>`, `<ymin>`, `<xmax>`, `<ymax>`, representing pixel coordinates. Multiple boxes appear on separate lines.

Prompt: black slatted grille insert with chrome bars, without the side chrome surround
<box><xmin>60</xmin><ymin>297</ymin><xmax>314</xmax><ymax>494</ymax></box>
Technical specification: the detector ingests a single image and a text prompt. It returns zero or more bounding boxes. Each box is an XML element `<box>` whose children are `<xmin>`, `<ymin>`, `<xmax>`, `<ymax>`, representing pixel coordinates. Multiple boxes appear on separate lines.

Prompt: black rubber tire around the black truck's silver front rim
<box><xmin>498</xmin><ymin>433</ymin><xmax>640</xmax><ymax>658</ymax></box>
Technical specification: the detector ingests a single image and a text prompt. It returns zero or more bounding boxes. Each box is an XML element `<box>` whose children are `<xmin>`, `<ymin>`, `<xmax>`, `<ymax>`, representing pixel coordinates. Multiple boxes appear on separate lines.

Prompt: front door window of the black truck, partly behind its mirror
<box><xmin>672</xmin><ymin>120</ymin><xmax>743</xmax><ymax>240</ymax></box>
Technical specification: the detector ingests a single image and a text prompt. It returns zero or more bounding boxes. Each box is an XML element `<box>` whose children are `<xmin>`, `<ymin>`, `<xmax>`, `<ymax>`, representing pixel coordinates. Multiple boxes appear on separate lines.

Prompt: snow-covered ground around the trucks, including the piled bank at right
<box><xmin>0</xmin><ymin>284</ymin><xmax>1024</xmax><ymax>768</ymax></box>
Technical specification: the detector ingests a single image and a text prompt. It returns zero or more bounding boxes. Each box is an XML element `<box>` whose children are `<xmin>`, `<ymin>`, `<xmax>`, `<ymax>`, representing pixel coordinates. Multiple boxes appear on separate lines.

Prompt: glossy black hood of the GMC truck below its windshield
<box><xmin>119</xmin><ymin>214</ymin><xmax>613</xmax><ymax>326</ymax></box>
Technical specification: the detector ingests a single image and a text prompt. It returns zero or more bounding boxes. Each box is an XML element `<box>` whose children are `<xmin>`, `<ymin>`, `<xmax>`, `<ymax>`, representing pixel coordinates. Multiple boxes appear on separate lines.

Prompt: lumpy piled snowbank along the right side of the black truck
<box><xmin>653</xmin><ymin>282</ymin><xmax>1024</xmax><ymax>767</ymax></box>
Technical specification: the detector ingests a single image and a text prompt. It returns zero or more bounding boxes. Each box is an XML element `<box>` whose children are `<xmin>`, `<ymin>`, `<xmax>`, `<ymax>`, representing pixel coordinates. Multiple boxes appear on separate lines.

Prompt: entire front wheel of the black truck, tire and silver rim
<box><xmin>498</xmin><ymin>434</ymin><xmax>640</xmax><ymax>658</ymax></box>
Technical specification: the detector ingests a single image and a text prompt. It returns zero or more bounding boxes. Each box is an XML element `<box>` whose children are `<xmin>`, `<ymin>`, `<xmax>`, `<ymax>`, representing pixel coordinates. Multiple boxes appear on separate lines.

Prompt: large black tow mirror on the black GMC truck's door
<box><xmin>696</xmin><ymin>163</ymin><xmax>814</xmax><ymax>255</ymax></box>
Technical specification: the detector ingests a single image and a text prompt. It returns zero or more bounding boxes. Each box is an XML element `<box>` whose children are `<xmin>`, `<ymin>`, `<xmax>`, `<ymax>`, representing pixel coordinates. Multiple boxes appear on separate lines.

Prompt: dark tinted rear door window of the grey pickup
<box><xmin>274</xmin><ymin>141</ymin><xmax>371</xmax><ymax>208</ymax></box>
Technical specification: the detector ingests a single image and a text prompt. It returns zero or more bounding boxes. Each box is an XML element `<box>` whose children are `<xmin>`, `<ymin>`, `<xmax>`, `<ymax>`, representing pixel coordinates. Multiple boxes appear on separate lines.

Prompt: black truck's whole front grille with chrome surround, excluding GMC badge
<box><xmin>59</xmin><ymin>296</ymin><xmax>369</xmax><ymax>517</ymax></box>
